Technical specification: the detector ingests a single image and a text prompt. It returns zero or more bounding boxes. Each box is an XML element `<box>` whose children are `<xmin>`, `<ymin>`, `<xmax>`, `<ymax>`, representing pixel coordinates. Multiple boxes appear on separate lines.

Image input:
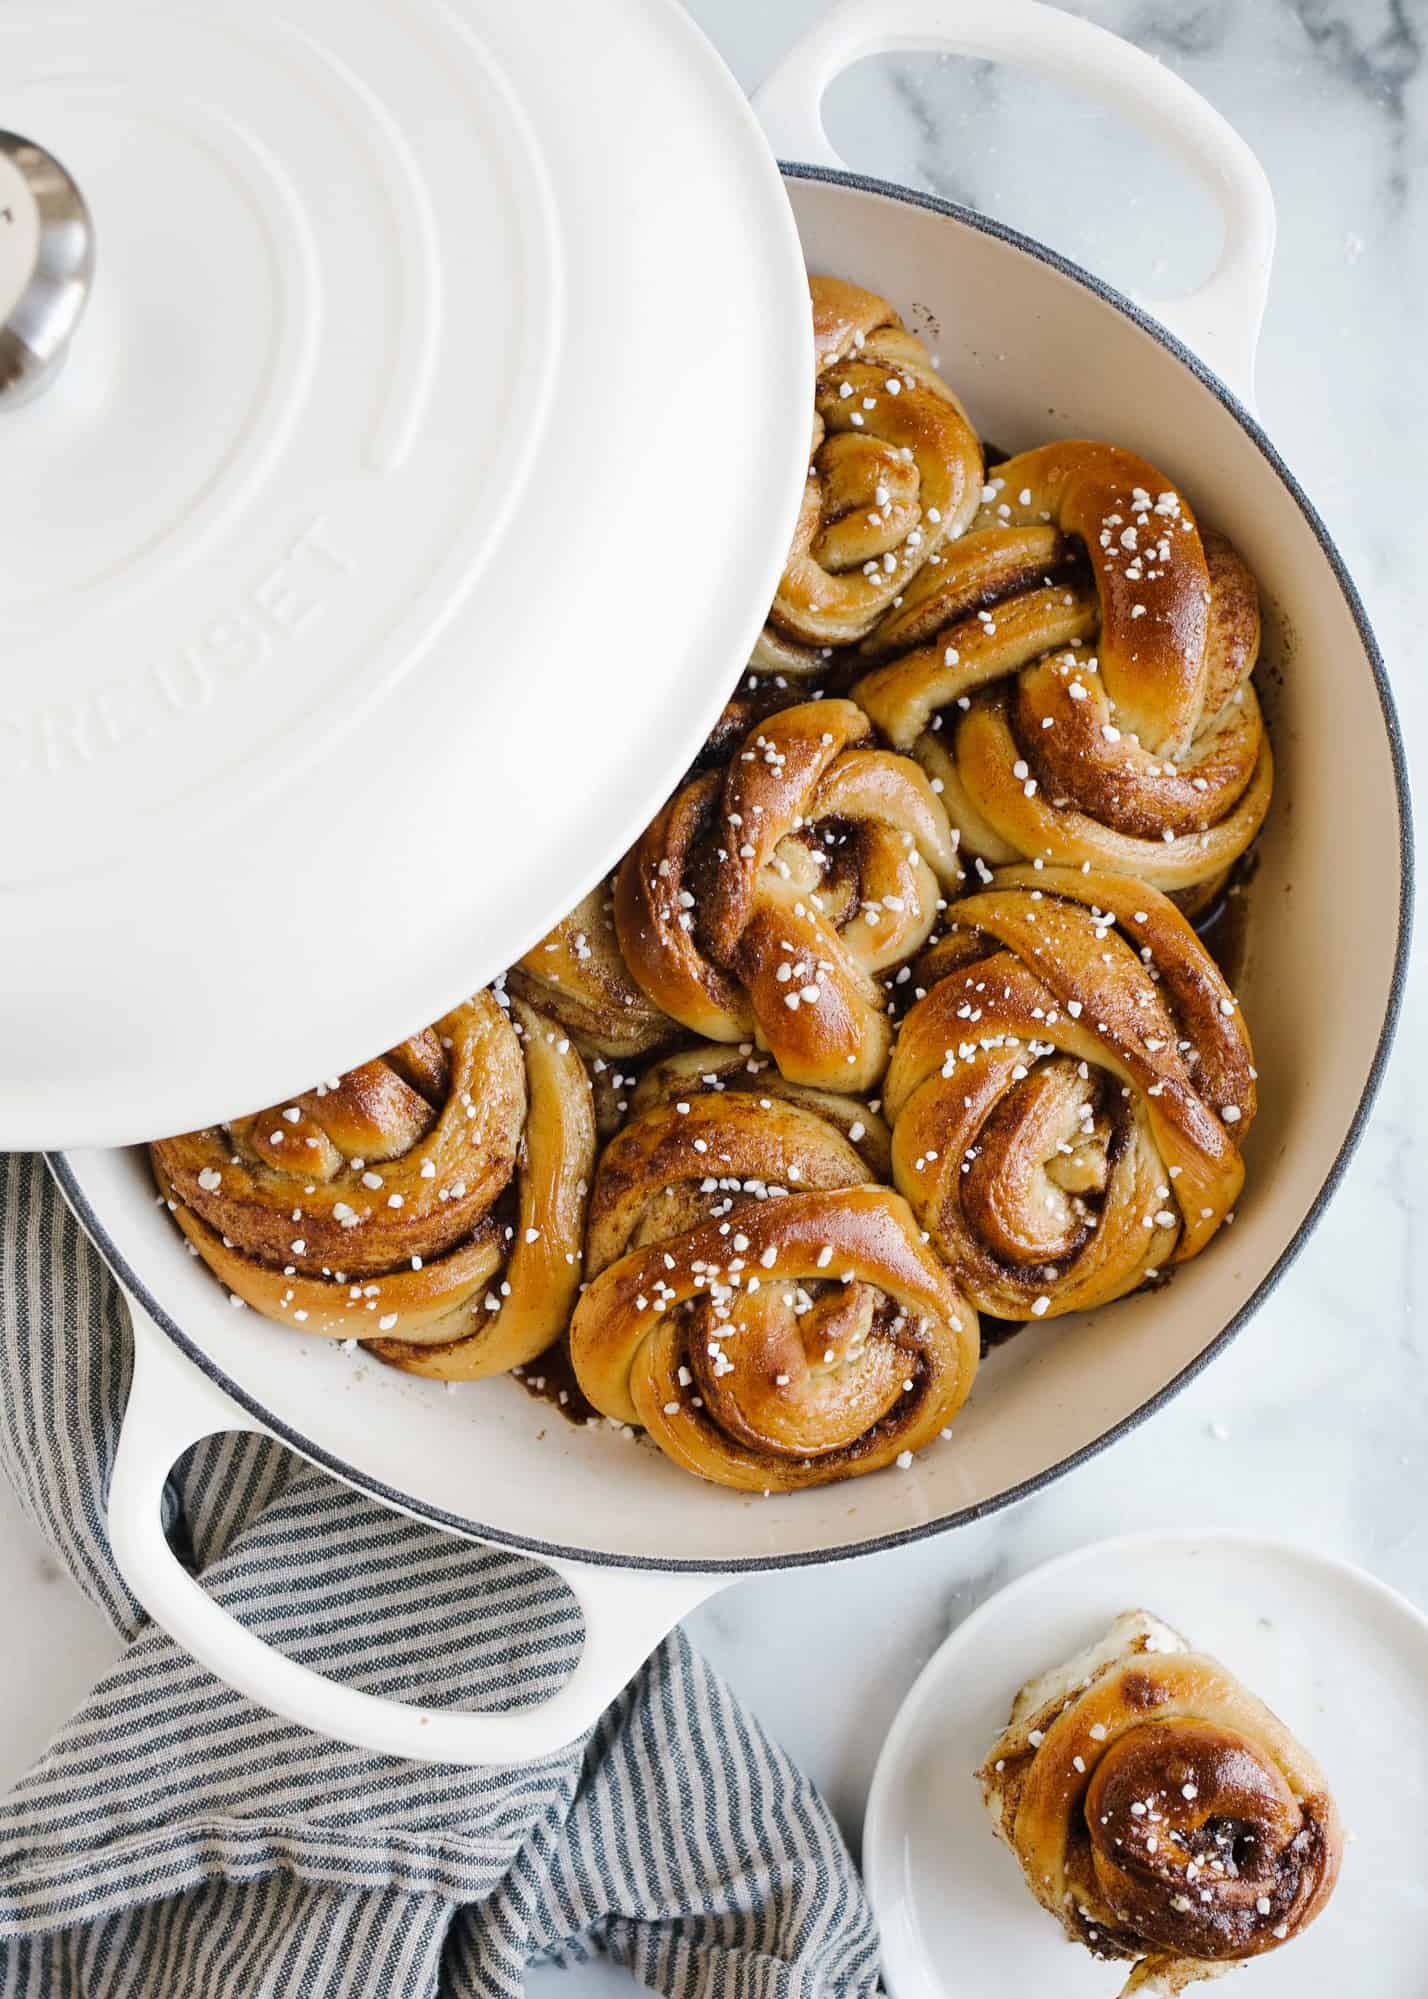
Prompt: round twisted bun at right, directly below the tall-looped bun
<box><xmin>884</xmin><ymin>868</ymin><xmax>1256</xmax><ymax>1319</ymax></box>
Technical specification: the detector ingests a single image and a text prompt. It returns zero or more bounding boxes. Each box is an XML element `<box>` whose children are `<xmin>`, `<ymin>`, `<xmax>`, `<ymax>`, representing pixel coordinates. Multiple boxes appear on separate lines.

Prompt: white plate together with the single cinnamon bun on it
<box><xmin>864</xmin><ymin>1535</ymin><xmax>1428</xmax><ymax>1999</ymax></box>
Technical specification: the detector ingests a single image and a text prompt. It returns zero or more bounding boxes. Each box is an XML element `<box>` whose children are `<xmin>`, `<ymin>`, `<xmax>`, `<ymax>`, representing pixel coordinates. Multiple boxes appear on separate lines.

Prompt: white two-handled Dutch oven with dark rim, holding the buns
<box><xmin>22</xmin><ymin>0</ymin><xmax>1410</xmax><ymax>1761</ymax></box>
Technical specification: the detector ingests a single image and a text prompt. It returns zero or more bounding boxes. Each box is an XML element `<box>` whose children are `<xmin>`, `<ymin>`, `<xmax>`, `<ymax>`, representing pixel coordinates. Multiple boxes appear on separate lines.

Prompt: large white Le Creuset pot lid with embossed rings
<box><xmin>0</xmin><ymin>0</ymin><xmax>812</xmax><ymax>1147</ymax></box>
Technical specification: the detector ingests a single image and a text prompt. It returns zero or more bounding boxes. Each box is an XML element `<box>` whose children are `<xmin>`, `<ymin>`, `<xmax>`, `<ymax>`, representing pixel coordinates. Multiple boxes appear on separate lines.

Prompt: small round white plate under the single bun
<box><xmin>864</xmin><ymin>1533</ymin><xmax>1428</xmax><ymax>1999</ymax></box>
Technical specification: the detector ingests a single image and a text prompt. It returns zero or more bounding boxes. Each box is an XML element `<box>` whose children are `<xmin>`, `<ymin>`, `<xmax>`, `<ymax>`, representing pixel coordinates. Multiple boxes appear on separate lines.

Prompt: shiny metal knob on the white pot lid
<box><xmin>0</xmin><ymin>132</ymin><xmax>94</xmax><ymax>410</ymax></box>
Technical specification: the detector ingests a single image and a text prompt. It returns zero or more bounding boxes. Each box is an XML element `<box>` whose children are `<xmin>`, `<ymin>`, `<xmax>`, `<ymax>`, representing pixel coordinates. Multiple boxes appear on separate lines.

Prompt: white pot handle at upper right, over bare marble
<box><xmin>754</xmin><ymin>0</ymin><xmax>1274</xmax><ymax>408</ymax></box>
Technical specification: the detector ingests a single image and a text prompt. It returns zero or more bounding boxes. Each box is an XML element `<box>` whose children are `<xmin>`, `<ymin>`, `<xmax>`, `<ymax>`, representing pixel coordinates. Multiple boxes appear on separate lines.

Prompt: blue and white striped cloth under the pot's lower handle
<box><xmin>0</xmin><ymin>1155</ymin><xmax>876</xmax><ymax>1999</ymax></box>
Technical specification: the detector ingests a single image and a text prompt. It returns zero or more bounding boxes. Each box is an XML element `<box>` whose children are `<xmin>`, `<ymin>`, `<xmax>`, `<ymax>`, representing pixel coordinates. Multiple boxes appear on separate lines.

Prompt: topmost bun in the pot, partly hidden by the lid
<box><xmin>756</xmin><ymin>278</ymin><xmax>982</xmax><ymax>643</ymax></box>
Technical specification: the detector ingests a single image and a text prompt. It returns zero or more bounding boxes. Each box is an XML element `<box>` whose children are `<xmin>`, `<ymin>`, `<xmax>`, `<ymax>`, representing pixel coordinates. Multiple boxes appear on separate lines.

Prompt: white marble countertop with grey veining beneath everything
<box><xmin>0</xmin><ymin>0</ymin><xmax>1428</xmax><ymax>1999</ymax></box>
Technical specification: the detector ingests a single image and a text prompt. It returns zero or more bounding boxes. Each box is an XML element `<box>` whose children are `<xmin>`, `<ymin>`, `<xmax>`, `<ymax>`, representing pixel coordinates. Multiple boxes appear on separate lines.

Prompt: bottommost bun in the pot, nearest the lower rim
<box><xmin>570</xmin><ymin>1085</ymin><xmax>978</xmax><ymax>1491</ymax></box>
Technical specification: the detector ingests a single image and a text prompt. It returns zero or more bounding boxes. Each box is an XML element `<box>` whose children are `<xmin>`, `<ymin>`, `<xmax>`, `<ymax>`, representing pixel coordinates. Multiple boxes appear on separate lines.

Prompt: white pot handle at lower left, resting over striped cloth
<box><xmin>108</xmin><ymin>1299</ymin><xmax>730</xmax><ymax>1765</ymax></box>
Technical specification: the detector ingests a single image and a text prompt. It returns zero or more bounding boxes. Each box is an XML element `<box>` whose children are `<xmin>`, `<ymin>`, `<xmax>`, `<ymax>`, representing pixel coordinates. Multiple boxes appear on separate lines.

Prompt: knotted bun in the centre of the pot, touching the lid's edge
<box><xmin>614</xmin><ymin>702</ymin><xmax>960</xmax><ymax>1091</ymax></box>
